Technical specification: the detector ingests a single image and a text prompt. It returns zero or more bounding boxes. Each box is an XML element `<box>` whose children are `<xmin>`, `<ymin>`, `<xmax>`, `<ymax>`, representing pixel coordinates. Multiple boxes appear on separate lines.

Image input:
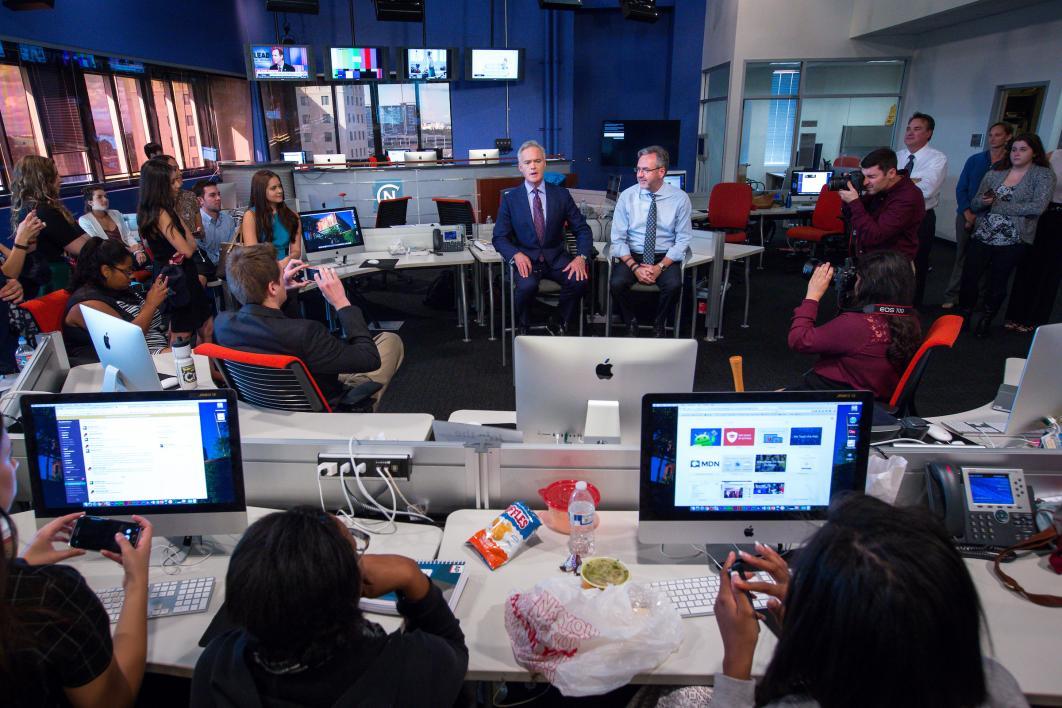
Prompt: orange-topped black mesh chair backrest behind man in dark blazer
<box><xmin>195</xmin><ymin>344</ymin><xmax>331</xmax><ymax>413</ymax></box>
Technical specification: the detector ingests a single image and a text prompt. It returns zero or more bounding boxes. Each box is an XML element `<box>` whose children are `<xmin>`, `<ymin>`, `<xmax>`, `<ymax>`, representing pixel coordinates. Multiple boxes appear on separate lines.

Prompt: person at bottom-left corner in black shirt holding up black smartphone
<box><xmin>0</xmin><ymin>427</ymin><xmax>152</xmax><ymax>708</ymax></box>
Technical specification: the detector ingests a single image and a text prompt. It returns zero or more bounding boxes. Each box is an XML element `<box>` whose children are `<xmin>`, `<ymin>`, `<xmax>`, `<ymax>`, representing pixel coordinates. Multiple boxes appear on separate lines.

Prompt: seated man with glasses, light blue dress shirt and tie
<box><xmin>609</xmin><ymin>145</ymin><xmax>693</xmax><ymax>336</ymax></box>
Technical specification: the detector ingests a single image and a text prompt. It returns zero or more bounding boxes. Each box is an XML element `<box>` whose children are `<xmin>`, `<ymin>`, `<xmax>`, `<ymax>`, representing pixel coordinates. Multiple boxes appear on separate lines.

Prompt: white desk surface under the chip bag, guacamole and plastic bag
<box><xmin>439</xmin><ymin>510</ymin><xmax>1062</xmax><ymax>705</ymax></box>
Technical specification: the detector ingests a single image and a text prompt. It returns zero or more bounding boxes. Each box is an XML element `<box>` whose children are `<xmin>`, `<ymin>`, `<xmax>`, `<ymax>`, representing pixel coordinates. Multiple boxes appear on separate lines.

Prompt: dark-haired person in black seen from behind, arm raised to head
<box><xmin>191</xmin><ymin>506</ymin><xmax>468</xmax><ymax>708</ymax></box>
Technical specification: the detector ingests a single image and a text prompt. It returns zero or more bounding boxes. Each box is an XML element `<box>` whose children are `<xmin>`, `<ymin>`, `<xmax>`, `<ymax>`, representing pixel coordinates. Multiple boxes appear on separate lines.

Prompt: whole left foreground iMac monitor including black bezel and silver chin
<box><xmin>22</xmin><ymin>388</ymin><xmax>247</xmax><ymax>536</ymax></box>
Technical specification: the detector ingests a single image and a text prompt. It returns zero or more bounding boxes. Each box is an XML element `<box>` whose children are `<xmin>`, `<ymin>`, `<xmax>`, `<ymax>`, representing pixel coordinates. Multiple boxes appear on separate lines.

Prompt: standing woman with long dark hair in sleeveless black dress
<box><xmin>136</xmin><ymin>159</ymin><xmax>213</xmax><ymax>342</ymax></box>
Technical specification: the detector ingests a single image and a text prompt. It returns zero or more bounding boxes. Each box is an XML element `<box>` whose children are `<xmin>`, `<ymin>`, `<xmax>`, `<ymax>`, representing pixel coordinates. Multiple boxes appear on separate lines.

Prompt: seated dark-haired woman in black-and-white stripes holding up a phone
<box><xmin>63</xmin><ymin>239</ymin><xmax>170</xmax><ymax>364</ymax></box>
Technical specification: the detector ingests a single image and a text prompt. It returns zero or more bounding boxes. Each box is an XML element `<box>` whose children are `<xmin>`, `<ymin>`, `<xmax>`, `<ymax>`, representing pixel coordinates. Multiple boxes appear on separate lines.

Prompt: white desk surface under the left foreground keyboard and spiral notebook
<box><xmin>14</xmin><ymin>506</ymin><xmax>442</xmax><ymax>676</ymax></box>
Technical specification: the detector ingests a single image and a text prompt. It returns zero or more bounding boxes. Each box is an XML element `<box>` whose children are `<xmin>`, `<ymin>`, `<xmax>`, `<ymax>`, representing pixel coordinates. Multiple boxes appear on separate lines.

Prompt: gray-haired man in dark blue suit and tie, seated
<box><xmin>493</xmin><ymin>140</ymin><xmax>594</xmax><ymax>334</ymax></box>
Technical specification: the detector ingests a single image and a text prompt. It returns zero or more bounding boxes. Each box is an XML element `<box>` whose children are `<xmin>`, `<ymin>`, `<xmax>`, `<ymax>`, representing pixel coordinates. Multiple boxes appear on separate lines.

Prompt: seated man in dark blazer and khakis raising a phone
<box><xmin>213</xmin><ymin>243</ymin><xmax>404</xmax><ymax>409</ymax></box>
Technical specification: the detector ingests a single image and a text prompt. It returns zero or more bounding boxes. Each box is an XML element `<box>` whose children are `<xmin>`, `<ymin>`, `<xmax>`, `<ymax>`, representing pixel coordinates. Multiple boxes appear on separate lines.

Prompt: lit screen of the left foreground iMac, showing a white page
<box><xmin>32</xmin><ymin>398</ymin><xmax>242</xmax><ymax>514</ymax></box>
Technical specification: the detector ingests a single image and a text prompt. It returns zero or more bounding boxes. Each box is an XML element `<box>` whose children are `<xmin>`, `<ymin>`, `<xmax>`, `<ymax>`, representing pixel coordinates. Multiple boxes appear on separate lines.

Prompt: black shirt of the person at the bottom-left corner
<box><xmin>0</xmin><ymin>559</ymin><xmax>113</xmax><ymax>706</ymax></box>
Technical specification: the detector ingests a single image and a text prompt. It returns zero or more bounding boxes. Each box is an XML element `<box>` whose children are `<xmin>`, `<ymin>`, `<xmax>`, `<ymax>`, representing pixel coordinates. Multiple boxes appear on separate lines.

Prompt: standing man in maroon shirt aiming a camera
<box><xmin>840</xmin><ymin>148</ymin><xmax>926</xmax><ymax>261</ymax></box>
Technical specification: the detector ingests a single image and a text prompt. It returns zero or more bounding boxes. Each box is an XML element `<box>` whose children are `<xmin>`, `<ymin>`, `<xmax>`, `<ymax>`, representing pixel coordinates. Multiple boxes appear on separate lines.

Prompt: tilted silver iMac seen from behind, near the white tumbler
<box><xmin>81</xmin><ymin>307</ymin><xmax>167</xmax><ymax>392</ymax></box>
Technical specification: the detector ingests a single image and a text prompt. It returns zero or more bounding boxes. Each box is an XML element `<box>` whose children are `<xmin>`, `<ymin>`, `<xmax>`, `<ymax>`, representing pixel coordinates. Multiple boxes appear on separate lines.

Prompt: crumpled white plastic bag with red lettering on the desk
<box><xmin>506</xmin><ymin>576</ymin><xmax>683</xmax><ymax>696</ymax></box>
